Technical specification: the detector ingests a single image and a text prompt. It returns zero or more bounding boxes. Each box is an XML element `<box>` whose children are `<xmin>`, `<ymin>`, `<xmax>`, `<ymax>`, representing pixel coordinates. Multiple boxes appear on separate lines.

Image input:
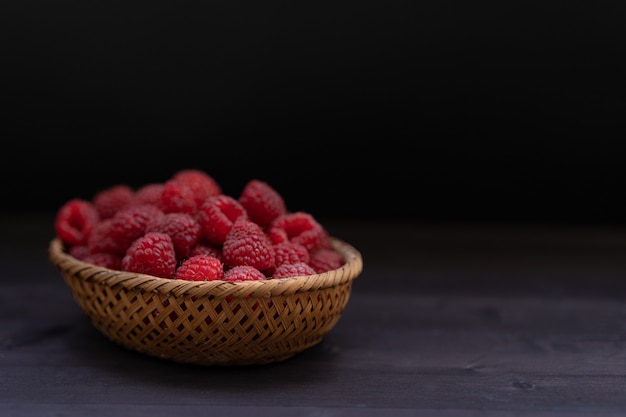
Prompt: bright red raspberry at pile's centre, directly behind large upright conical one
<box><xmin>197</xmin><ymin>194</ymin><xmax>248</xmax><ymax>246</ymax></box>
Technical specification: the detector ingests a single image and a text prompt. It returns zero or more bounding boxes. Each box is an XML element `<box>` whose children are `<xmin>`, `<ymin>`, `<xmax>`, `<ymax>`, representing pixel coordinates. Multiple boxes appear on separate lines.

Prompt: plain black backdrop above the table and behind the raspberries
<box><xmin>0</xmin><ymin>1</ymin><xmax>626</xmax><ymax>226</ymax></box>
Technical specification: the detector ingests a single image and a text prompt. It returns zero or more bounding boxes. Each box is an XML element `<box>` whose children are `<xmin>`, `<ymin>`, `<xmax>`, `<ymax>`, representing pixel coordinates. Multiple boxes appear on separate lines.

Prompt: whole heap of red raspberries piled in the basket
<box><xmin>54</xmin><ymin>169</ymin><xmax>345</xmax><ymax>282</ymax></box>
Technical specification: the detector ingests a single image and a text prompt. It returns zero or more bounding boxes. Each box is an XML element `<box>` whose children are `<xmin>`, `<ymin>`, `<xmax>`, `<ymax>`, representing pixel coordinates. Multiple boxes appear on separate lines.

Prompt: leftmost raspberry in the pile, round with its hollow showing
<box><xmin>54</xmin><ymin>198</ymin><xmax>100</xmax><ymax>247</ymax></box>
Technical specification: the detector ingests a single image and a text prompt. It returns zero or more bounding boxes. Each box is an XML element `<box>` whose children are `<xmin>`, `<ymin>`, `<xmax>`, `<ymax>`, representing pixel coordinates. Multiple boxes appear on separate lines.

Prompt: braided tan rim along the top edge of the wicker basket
<box><xmin>48</xmin><ymin>236</ymin><xmax>363</xmax><ymax>298</ymax></box>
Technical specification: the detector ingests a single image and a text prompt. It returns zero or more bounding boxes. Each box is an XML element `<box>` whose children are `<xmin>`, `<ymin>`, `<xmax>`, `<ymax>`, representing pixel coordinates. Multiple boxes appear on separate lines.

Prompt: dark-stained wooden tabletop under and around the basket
<box><xmin>0</xmin><ymin>214</ymin><xmax>626</xmax><ymax>417</ymax></box>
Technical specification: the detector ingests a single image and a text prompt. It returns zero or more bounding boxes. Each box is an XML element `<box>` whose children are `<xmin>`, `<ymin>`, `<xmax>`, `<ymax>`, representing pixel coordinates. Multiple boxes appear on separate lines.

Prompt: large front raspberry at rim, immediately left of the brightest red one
<box><xmin>121</xmin><ymin>233</ymin><xmax>176</xmax><ymax>278</ymax></box>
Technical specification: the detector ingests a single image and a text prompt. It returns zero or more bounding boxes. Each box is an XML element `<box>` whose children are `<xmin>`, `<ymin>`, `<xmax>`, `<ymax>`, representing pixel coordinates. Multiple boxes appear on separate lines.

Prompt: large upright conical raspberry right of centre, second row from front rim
<box><xmin>222</xmin><ymin>220</ymin><xmax>275</xmax><ymax>271</ymax></box>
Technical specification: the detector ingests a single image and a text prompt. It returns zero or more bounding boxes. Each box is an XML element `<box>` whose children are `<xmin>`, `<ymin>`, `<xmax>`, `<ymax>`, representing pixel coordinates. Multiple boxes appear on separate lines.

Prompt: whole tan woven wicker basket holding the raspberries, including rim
<box><xmin>48</xmin><ymin>237</ymin><xmax>363</xmax><ymax>366</ymax></box>
